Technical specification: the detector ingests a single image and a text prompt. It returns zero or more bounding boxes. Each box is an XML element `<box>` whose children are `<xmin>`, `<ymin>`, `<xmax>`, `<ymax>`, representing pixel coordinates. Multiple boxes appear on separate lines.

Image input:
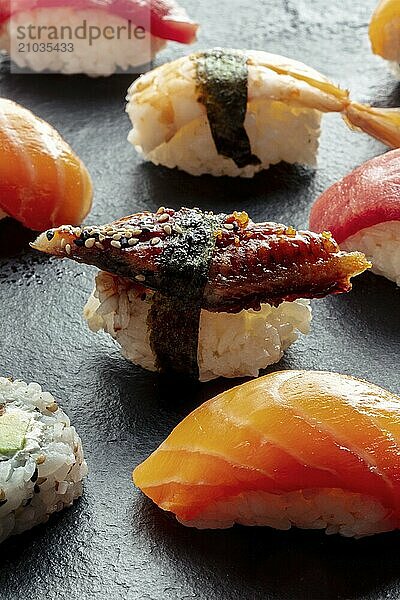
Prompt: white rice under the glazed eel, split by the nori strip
<box><xmin>84</xmin><ymin>272</ymin><xmax>311</xmax><ymax>381</ymax></box>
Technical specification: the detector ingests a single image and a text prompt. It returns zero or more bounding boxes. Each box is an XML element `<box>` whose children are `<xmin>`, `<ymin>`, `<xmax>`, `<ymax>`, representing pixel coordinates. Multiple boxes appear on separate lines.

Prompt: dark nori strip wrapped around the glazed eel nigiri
<box><xmin>147</xmin><ymin>209</ymin><xmax>225</xmax><ymax>379</ymax></box>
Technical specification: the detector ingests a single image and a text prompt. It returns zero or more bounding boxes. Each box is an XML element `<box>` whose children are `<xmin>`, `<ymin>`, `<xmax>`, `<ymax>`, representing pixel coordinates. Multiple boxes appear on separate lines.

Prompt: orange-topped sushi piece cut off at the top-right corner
<box><xmin>369</xmin><ymin>0</ymin><xmax>400</xmax><ymax>79</ymax></box>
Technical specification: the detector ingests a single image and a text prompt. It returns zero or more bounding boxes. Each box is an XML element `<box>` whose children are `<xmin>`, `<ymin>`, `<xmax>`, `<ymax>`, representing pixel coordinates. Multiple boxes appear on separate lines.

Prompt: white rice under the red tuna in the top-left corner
<box><xmin>0</xmin><ymin>7</ymin><xmax>166</xmax><ymax>77</ymax></box>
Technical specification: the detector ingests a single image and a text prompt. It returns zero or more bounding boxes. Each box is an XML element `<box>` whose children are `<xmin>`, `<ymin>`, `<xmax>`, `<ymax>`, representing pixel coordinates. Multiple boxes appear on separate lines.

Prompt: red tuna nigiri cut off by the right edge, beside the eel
<box><xmin>310</xmin><ymin>150</ymin><xmax>400</xmax><ymax>285</ymax></box>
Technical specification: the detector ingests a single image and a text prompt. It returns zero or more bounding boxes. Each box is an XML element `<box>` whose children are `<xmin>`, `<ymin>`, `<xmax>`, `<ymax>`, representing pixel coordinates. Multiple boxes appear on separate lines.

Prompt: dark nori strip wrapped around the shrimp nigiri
<box><xmin>195</xmin><ymin>48</ymin><xmax>261</xmax><ymax>168</ymax></box>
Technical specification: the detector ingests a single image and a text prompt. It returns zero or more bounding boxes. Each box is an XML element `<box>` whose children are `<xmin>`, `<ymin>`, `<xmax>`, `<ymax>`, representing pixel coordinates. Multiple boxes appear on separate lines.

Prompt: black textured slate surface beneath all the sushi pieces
<box><xmin>0</xmin><ymin>0</ymin><xmax>400</xmax><ymax>600</ymax></box>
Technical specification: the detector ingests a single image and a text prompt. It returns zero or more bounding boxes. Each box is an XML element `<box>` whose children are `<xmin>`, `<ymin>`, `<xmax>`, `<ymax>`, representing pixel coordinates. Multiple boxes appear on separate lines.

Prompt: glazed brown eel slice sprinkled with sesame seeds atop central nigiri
<box><xmin>32</xmin><ymin>207</ymin><xmax>371</xmax><ymax>313</ymax></box>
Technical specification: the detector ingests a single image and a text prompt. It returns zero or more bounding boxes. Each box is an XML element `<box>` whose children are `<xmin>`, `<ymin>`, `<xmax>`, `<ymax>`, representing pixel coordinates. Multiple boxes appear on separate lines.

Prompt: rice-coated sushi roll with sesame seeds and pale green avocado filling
<box><xmin>0</xmin><ymin>377</ymin><xmax>87</xmax><ymax>542</ymax></box>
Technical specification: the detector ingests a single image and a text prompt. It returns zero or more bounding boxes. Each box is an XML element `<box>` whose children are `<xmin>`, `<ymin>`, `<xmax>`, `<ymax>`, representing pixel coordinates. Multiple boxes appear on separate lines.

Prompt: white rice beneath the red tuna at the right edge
<box><xmin>340</xmin><ymin>221</ymin><xmax>400</xmax><ymax>286</ymax></box>
